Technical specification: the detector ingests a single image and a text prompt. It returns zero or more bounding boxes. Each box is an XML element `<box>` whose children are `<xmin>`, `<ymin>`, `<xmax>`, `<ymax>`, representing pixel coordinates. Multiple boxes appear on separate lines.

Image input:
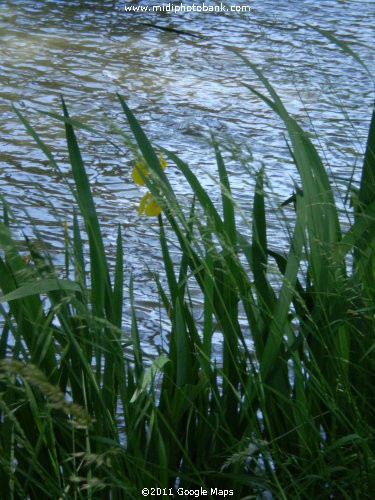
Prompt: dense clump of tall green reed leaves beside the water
<box><xmin>0</xmin><ymin>48</ymin><xmax>375</xmax><ymax>499</ymax></box>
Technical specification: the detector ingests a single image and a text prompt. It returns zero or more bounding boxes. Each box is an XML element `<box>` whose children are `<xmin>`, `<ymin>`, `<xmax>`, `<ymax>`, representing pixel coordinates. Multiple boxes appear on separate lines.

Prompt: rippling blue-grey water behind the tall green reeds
<box><xmin>0</xmin><ymin>0</ymin><xmax>375</xmax><ymax>356</ymax></box>
